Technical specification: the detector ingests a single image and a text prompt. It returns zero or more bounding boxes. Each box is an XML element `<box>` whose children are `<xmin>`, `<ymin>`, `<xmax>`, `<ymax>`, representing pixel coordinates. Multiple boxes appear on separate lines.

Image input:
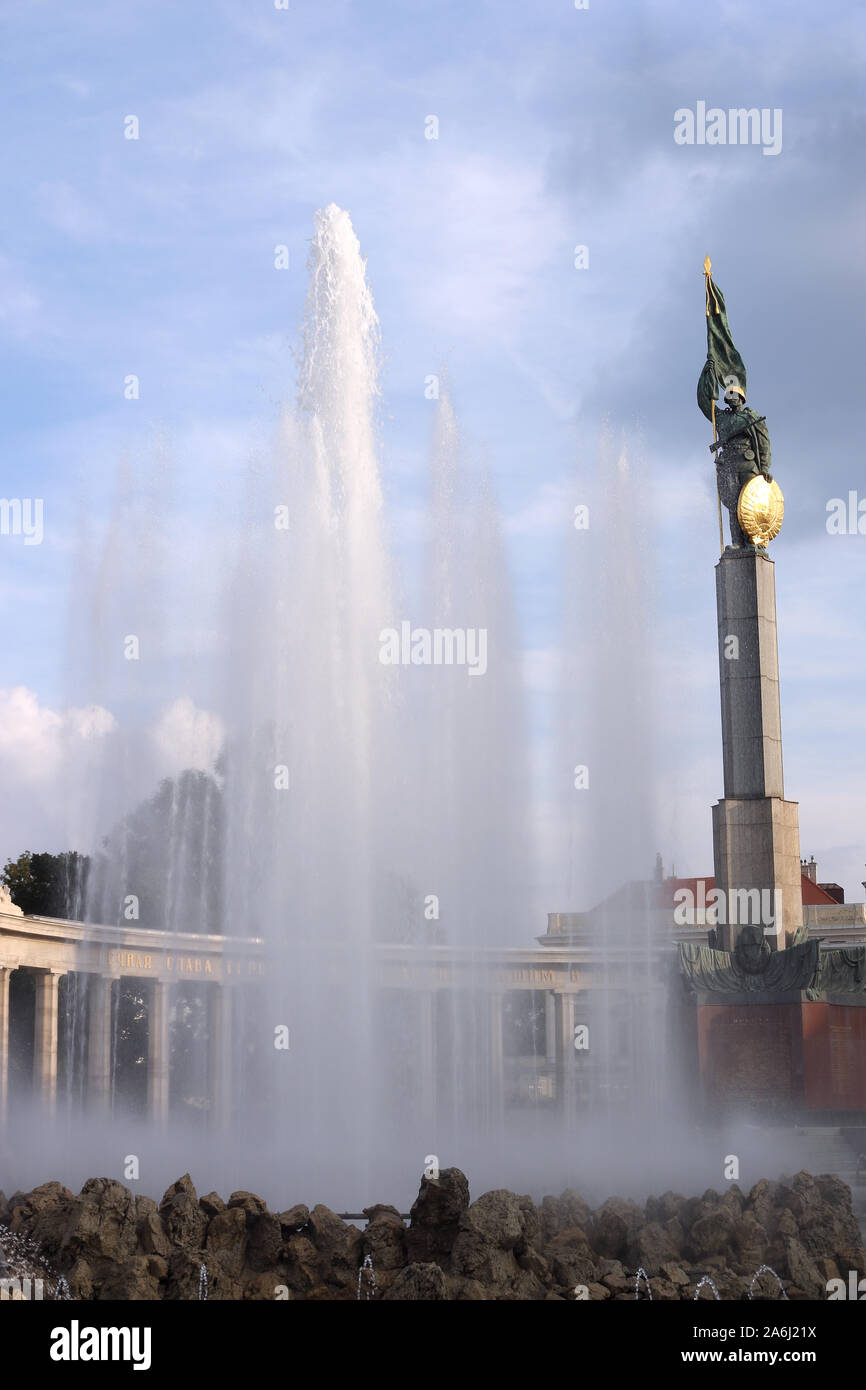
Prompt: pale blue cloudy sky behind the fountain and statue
<box><xmin>0</xmin><ymin>0</ymin><xmax>866</xmax><ymax>910</ymax></box>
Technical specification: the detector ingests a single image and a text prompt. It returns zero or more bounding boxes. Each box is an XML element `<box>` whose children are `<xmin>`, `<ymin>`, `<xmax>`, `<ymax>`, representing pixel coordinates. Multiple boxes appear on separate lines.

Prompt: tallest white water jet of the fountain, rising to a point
<box><xmin>219</xmin><ymin>206</ymin><xmax>395</xmax><ymax>1201</ymax></box>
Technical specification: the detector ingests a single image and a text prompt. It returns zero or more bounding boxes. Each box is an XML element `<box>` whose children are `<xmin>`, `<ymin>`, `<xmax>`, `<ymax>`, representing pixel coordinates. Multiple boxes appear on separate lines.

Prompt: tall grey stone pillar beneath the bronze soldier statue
<box><xmin>713</xmin><ymin>549</ymin><xmax>802</xmax><ymax>951</ymax></box>
